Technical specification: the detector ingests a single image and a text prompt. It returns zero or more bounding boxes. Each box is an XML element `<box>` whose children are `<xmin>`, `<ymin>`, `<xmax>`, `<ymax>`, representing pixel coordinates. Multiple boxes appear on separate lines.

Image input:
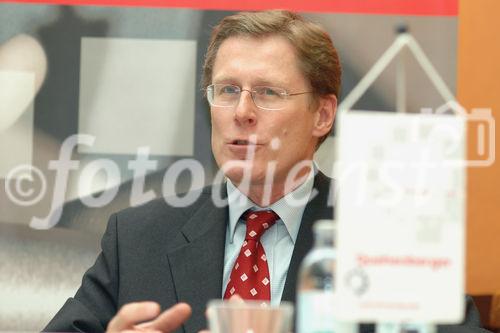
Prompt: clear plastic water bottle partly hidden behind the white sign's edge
<box><xmin>297</xmin><ymin>220</ymin><xmax>358</xmax><ymax>333</ymax></box>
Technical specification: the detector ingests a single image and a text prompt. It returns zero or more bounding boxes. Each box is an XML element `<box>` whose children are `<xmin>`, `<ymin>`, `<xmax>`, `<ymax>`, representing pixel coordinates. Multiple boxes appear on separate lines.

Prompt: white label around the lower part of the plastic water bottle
<box><xmin>297</xmin><ymin>290</ymin><xmax>357</xmax><ymax>333</ymax></box>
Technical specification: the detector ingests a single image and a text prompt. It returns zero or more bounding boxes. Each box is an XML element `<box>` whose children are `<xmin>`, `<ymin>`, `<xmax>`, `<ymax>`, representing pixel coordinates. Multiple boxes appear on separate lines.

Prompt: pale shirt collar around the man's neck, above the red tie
<box><xmin>226</xmin><ymin>164</ymin><xmax>317</xmax><ymax>244</ymax></box>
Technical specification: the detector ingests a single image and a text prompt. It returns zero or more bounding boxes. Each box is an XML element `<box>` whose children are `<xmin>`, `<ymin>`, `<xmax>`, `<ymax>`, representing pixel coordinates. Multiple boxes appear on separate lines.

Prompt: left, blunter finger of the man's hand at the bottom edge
<box><xmin>107</xmin><ymin>302</ymin><xmax>160</xmax><ymax>332</ymax></box>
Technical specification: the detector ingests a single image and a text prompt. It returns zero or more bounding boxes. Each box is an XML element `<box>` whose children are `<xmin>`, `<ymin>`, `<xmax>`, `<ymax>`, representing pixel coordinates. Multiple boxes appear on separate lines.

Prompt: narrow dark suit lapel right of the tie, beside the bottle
<box><xmin>281</xmin><ymin>172</ymin><xmax>333</xmax><ymax>302</ymax></box>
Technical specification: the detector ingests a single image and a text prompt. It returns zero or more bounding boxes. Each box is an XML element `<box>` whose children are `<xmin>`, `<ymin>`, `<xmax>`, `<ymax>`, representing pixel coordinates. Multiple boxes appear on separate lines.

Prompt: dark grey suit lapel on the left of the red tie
<box><xmin>168</xmin><ymin>188</ymin><xmax>228</xmax><ymax>332</ymax></box>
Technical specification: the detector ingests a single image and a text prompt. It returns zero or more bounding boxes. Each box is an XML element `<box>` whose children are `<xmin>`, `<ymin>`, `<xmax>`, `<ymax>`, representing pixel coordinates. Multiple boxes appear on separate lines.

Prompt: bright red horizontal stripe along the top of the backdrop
<box><xmin>0</xmin><ymin>0</ymin><xmax>458</xmax><ymax>16</ymax></box>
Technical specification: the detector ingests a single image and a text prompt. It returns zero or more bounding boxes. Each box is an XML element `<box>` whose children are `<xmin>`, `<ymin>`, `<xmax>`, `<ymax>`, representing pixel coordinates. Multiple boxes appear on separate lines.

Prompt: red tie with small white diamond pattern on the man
<box><xmin>224</xmin><ymin>210</ymin><xmax>279</xmax><ymax>301</ymax></box>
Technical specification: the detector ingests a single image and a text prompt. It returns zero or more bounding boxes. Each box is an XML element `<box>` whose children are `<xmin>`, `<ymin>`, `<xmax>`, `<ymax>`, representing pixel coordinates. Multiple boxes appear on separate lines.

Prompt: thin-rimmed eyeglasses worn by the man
<box><xmin>207</xmin><ymin>84</ymin><xmax>312</xmax><ymax>111</ymax></box>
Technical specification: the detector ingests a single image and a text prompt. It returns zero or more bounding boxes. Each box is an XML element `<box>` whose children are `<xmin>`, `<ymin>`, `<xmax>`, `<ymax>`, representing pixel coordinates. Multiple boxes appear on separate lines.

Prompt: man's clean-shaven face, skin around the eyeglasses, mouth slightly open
<box><xmin>210</xmin><ymin>36</ymin><xmax>327</xmax><ymax>185</ymax></box>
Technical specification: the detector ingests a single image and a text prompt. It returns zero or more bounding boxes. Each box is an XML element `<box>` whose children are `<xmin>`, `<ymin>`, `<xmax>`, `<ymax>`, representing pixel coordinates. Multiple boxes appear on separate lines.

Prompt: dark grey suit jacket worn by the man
<box><xmin>44</xmin><ymin>173</ymin><xmax>488</xmax><ymax>333</ymax></box>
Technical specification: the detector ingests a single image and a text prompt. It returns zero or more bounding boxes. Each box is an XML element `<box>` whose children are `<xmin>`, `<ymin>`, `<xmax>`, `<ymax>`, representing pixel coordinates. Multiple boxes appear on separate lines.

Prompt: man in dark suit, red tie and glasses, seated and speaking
<box><xmin>45</xmin><ymin>11</ymin><xmax>488</xmax><ymax>332</ymax></box>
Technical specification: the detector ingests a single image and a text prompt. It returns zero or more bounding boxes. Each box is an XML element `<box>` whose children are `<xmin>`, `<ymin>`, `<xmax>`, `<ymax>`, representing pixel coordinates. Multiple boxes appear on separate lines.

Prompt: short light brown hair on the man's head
<box><xmin>202</xmin><ymin>10</ymin><xmax>342</xmax><ymax>146</ymax></box>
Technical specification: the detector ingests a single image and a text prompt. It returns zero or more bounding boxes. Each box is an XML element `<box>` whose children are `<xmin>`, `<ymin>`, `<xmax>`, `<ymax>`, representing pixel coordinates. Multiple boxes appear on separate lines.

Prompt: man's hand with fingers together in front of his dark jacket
<box><xmin>106</xmin><ymin>302</ymin><xmax>191</xmax><ymax>333</ymax></box>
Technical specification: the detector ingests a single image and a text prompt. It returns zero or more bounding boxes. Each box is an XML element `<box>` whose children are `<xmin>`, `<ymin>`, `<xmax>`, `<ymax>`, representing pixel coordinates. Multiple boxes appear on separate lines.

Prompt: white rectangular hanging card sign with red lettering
<box><xmin>334</xmin><ymin>111</ymin><xmax>466</xmax><ymax>323</ymax></box>
